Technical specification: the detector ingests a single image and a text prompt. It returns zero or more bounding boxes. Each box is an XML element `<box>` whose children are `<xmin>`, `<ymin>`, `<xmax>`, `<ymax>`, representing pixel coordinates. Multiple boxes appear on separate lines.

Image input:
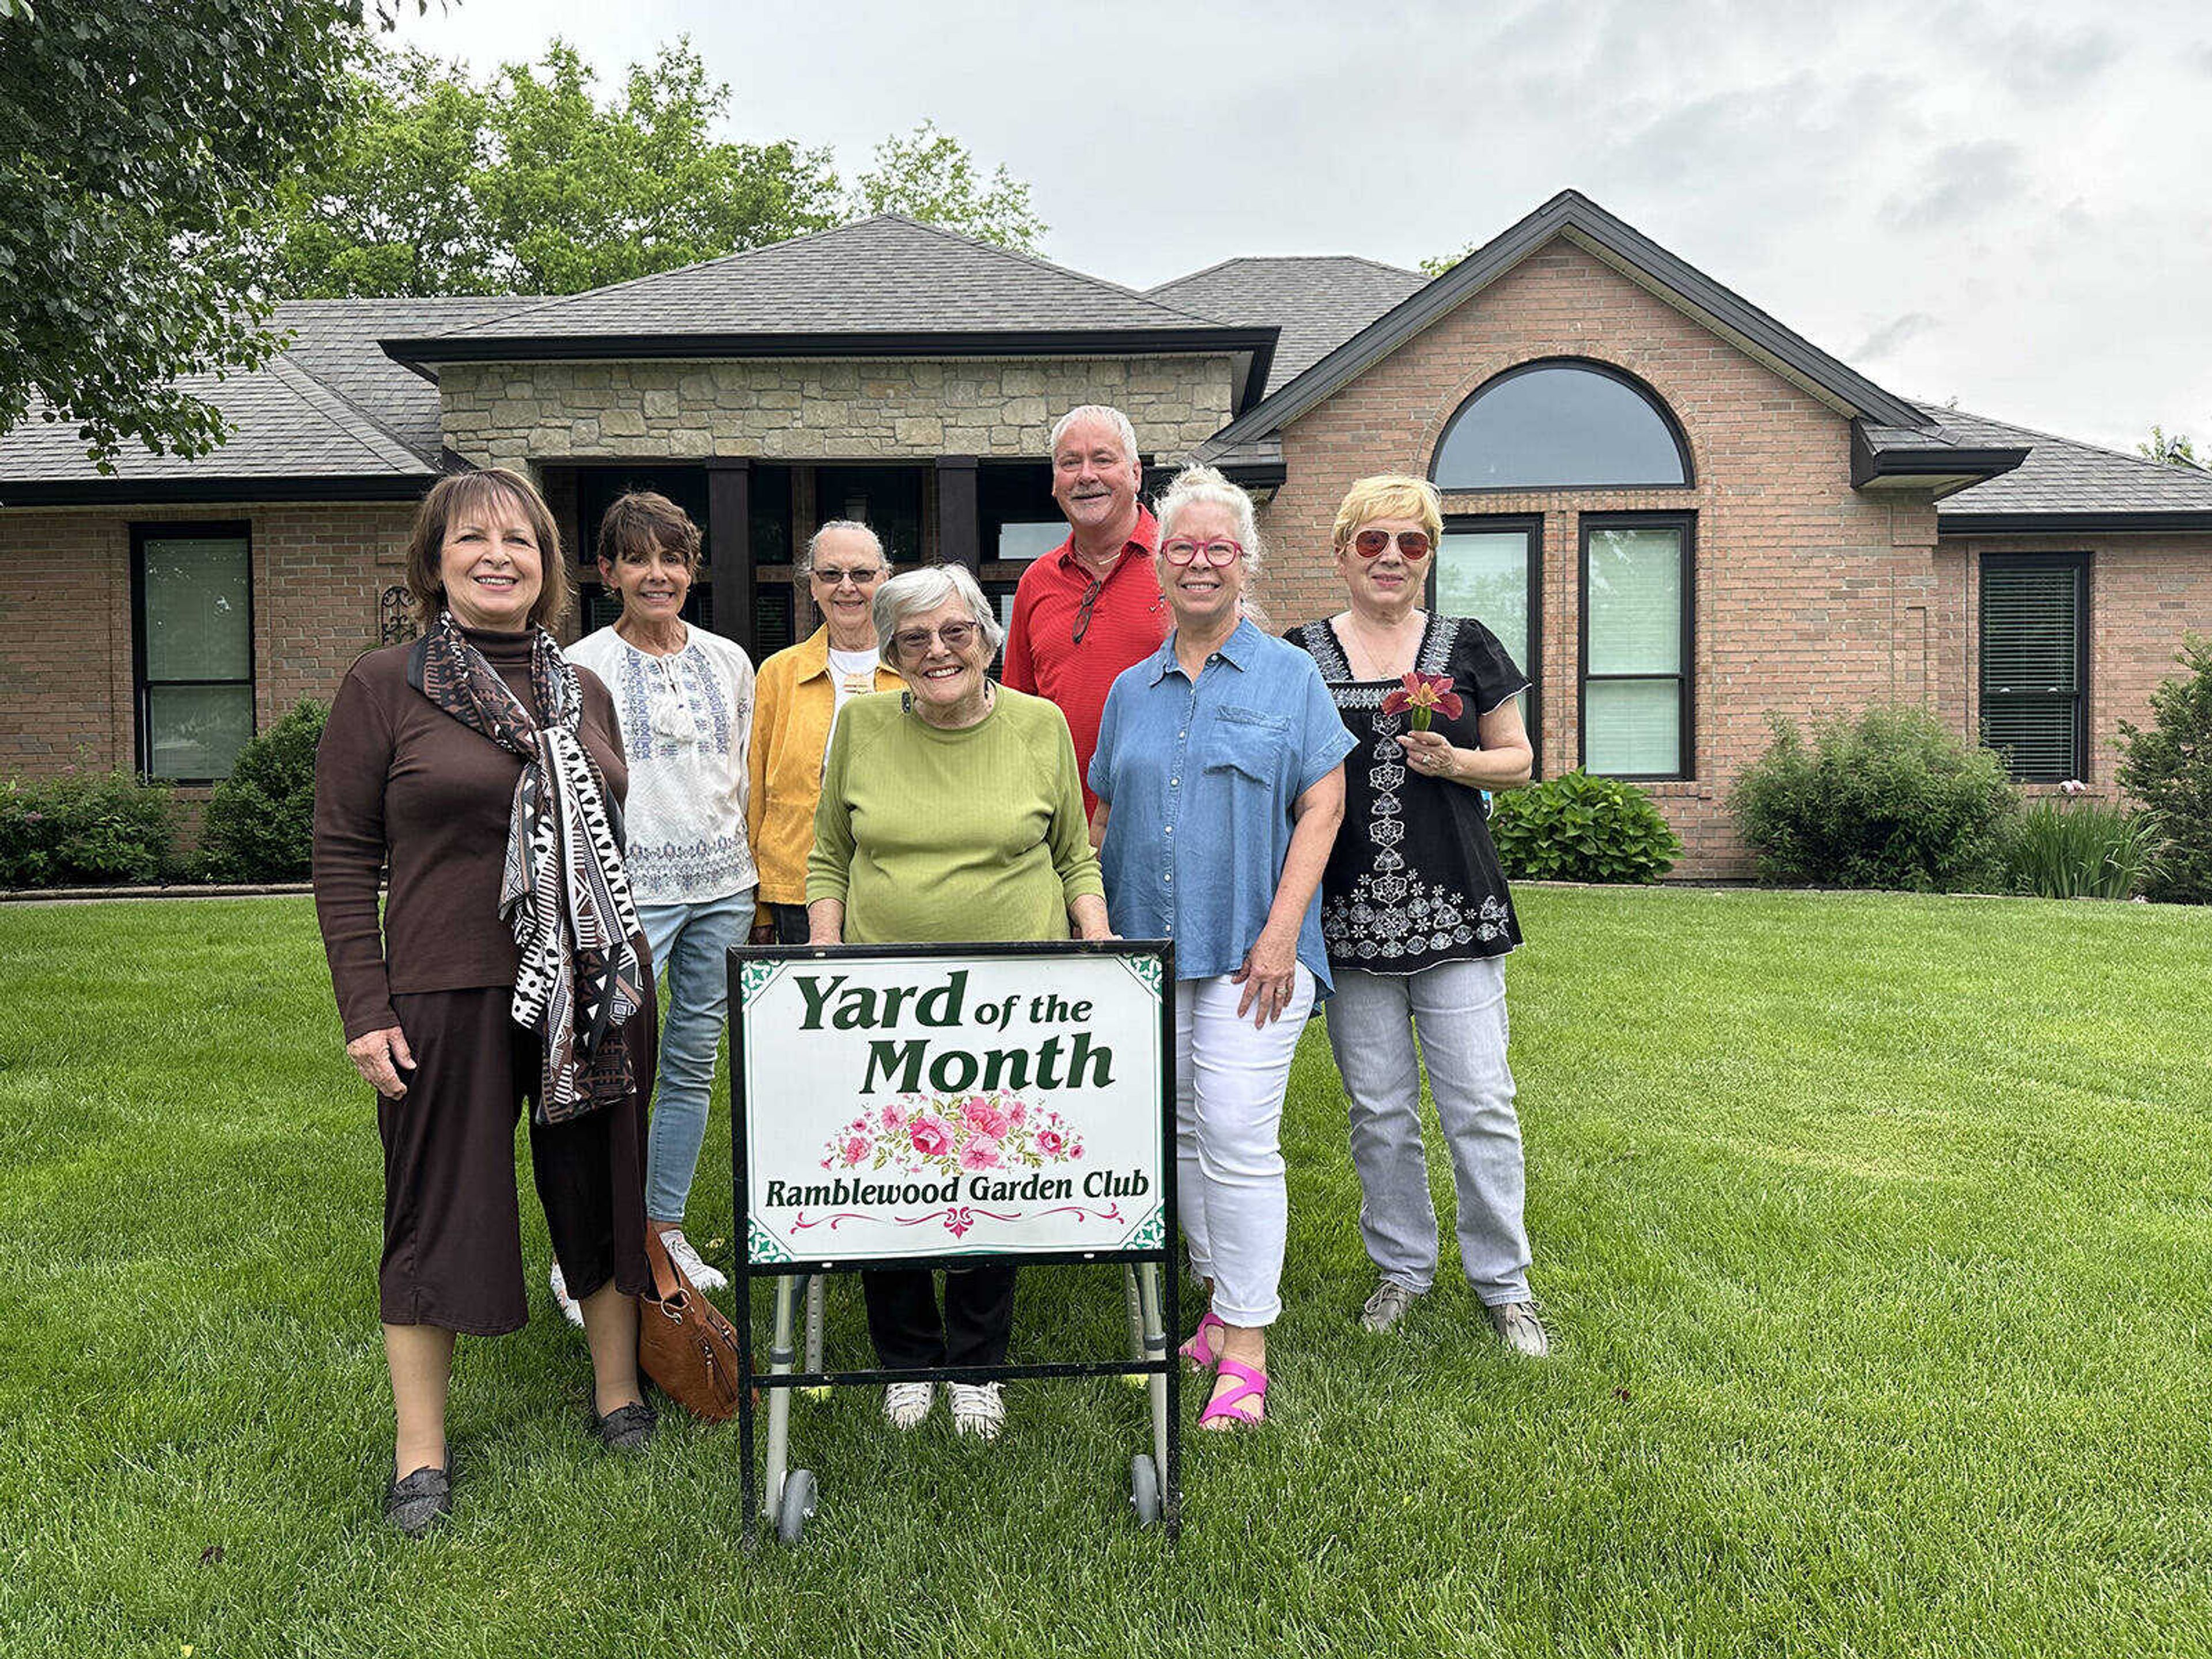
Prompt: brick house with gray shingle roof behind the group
<box><xmin>0</xmin><ymin>190</ymin><xmax>2212</xmax><ymax>876</ymax></box>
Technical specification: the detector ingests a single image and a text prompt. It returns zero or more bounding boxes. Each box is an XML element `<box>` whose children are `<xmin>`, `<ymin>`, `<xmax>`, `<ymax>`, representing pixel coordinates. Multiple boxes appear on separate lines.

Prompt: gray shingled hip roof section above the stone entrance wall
<box><xmin>385</xmin><ymin>213</ymin><xmax>1219</xmax><ymax>351</ymax></box>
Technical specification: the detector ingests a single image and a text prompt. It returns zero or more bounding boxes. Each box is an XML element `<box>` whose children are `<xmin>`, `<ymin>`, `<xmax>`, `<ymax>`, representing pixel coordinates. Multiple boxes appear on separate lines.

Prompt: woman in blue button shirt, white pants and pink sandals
<box><xmin>1090</xmin><ymin>467</ymin><xmax>1354</xmax><ymax>1429</ymax></box>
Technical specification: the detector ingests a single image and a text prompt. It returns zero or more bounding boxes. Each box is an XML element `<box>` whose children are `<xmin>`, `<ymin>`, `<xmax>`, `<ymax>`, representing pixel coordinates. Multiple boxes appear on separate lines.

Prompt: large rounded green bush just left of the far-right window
<box><xmin>1728</xmin><ymin>706</ymin><xmax>2020</xmax><ymax>892</ymax></box>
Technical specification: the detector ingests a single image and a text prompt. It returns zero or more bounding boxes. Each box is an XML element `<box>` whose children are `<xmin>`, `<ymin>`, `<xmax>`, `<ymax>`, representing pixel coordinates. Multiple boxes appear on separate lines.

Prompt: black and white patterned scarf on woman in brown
<box><xmin>407</xmin><ymin>611</ymin><xmax>650</xmax><ymax>1124</ymax></box>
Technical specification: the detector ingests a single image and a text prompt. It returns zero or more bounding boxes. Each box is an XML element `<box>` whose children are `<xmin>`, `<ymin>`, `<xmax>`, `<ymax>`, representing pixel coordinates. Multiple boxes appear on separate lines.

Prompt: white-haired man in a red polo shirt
<box><xmin>1004</xmin><ymin>403</ymin><xmax>1168</xmax><ymax>827</ymax></box>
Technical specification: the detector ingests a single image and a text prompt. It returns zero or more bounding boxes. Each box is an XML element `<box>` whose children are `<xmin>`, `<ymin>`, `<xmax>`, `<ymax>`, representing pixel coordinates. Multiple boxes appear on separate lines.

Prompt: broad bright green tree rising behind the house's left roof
<box><xmin>263</xmin><ymin>40</ymin><xmax>838</xmax><ymax>297</ymax></box>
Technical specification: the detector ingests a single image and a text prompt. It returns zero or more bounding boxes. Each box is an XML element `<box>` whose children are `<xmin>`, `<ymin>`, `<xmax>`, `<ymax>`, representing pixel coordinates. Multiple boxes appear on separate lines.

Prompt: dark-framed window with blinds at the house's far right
<box><xmin>1982</xmin><ymin>553</ymin><xmax>2088</xmax><ymax>783</ymax></box>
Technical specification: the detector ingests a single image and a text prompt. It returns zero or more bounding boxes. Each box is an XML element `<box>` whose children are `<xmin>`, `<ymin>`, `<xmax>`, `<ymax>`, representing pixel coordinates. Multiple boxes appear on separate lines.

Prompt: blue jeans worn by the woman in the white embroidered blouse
<box><xmin>637</xmin><ymin>887</ymin><xmax>754</xmax><ymax>1225</ymax></box>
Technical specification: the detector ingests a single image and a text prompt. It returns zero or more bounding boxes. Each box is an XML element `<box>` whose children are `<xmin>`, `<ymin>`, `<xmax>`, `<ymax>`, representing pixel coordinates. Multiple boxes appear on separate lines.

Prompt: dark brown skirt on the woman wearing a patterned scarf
<box><xmin>376</xmin><ymin>987</ymin><xmax>659</xmax><ymax>1336</ymax></box>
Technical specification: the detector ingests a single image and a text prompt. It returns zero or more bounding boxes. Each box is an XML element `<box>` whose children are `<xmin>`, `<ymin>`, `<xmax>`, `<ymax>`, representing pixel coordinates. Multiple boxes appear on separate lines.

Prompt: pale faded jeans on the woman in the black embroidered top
<box><xmin>1327</xmin><ymin>956</ymin><xmax>1528</xmax><ymax>1307</ymax></box>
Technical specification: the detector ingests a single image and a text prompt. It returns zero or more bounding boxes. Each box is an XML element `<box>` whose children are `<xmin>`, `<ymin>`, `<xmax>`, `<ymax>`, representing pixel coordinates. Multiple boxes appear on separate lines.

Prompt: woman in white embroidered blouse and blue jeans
<box><xmin>553</xmin><ymin>491</ymin><xmax>759</xmax><ymax>1319</ymax></box>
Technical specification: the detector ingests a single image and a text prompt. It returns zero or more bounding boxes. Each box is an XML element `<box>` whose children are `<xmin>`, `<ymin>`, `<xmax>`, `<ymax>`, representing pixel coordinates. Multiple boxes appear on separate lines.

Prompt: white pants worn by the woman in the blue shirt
<box><xmin>1175</xmin><ymin>967</ymin><xmax>1314</xmax><ymax>1325</ymax></box>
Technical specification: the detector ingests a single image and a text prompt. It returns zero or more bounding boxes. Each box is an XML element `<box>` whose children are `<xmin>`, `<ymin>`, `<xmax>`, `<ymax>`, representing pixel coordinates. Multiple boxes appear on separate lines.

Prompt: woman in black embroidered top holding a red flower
<box><xmin>1290</xmin><ymin>476</ymin><xmax>1546</xmax><ymax>1356</ymax></box>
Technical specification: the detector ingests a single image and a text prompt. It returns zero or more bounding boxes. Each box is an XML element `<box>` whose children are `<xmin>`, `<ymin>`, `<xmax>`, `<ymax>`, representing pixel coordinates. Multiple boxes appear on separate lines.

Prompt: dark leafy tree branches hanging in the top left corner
<box><xmin>0</xmin><ymin>0</ymin><xmax>421</xmax><ymax>471</ymax></box>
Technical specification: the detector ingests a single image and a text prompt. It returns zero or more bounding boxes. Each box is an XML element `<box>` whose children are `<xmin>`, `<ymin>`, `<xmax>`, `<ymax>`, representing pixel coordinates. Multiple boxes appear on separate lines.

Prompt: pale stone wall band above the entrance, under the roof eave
<box><xmin>438</xmin><ymin>356</ymin><xmax>1230</xmax><ymax>467</ymax></box>
